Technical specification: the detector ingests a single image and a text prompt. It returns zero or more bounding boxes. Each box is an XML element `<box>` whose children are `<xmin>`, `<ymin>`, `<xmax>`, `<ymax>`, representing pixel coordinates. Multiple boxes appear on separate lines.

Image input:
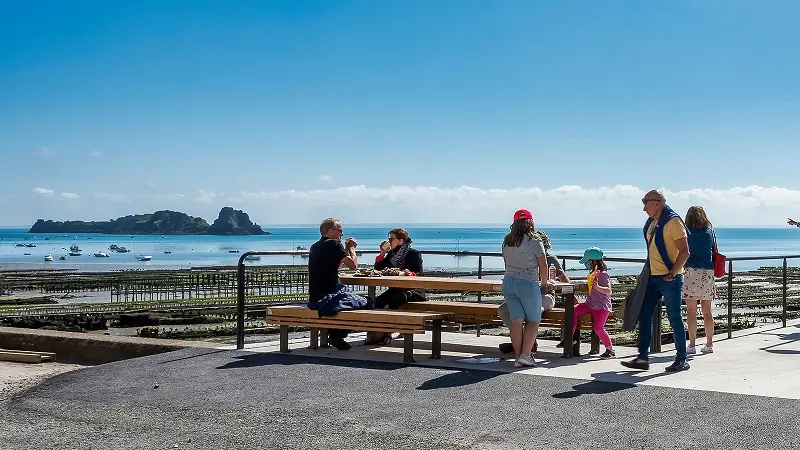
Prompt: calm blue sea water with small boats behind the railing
<box><xmin>0</xmin><ymin>226</ymin><xmax>800</xmax><ymax>274</ymax></box>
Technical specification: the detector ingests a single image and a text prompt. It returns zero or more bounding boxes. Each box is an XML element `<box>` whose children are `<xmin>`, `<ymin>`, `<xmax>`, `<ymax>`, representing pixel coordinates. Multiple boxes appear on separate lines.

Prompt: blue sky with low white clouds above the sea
<box><xmin>0</xmin><ymin>0</ymin><xmax>800</xmax><ymax>225</ymax></box>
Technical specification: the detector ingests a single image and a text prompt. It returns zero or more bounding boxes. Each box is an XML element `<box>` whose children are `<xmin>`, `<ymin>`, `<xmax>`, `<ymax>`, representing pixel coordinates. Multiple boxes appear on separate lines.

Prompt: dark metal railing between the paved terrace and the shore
<box><xmin>236</xmin><ymin>250</ymin><xmax>800</xmax><ymax>351</ymax></box>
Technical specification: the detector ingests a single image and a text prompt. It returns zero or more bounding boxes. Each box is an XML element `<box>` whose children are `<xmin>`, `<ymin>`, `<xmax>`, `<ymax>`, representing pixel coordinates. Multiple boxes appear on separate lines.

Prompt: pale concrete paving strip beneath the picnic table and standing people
<box><xmin>225</xmin><ymin>320</ymin><xmax>800</xmax><ymax>399</ymax></box>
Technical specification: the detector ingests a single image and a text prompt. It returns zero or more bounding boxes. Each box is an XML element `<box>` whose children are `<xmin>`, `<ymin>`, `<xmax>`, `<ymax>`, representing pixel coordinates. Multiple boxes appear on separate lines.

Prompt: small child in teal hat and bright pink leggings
<box><xmin>572</xmin><ymin>247</ymin><xmax>617</xmax><ymax>359</ymax></box>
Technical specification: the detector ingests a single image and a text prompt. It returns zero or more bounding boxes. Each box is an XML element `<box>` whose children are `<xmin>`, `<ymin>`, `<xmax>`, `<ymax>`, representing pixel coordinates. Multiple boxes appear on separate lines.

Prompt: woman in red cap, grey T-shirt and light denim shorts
<box><xmin>503</xmin><ymin>209</ymin><xmax>547</xmax><ymax>367</ymax></box>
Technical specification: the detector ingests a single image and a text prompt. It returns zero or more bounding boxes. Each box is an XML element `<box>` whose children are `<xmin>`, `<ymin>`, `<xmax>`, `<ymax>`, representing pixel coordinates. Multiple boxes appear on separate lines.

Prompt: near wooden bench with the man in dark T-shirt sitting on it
<box><xmin>267</xmin><ymin>305</ymin><xmax>453</xmax><ymax>363</ymax></box>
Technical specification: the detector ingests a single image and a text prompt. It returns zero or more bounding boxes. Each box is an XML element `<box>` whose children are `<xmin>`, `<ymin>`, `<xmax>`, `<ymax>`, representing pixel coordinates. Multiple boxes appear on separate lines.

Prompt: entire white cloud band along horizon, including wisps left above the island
<box><xmin>12</xmin><ymin>185</ymin><xmax>800</xmax><ymax>227</ymax></box>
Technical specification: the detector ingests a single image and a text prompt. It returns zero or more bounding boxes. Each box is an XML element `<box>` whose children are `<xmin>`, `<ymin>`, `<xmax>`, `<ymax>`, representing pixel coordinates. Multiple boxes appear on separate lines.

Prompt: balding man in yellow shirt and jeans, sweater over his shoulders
<box><xmin>622</xmin><ymin>190</ymin><xmax>689</xmax><ymax>372</ymax></box>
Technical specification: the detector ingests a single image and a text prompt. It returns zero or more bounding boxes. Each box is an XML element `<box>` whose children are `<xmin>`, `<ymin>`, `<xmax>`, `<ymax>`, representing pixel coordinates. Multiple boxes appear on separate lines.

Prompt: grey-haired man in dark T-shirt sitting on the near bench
<box><xmin>308</xmin><ymin>217</ymin><xmax>372</xmax><ymax>350</ymax></box>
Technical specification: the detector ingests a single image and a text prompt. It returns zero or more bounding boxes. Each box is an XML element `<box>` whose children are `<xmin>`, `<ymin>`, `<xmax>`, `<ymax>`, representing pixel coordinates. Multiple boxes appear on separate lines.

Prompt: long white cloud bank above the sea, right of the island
<box><xmin>228</xmin><ymin>185</ymin><xmax>800</xmax><ymax>226</ymax></box>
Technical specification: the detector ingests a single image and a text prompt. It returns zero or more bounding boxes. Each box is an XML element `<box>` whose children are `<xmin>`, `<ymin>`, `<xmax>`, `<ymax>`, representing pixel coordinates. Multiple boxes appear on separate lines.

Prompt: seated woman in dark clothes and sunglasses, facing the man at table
<box><xmin>364</xmin><ymin>228</ymin><xmax>426</xmax><ymax>345</ymax></box>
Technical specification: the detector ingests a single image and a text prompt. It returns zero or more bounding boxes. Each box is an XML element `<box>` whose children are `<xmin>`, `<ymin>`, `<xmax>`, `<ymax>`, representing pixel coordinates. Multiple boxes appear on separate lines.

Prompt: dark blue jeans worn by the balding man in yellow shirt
<box><xmin>639</xmin><ymin>275</ymin><xmax>686</xmax><ymax>361</ymax></box>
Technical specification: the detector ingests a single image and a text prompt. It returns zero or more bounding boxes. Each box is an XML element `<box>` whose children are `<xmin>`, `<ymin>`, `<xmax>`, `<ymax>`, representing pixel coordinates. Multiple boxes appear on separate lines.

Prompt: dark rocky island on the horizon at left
<box><xmin>28</xmin><ymin>206</ymin><xmax>270</xmax><ymax>236</ymax></box>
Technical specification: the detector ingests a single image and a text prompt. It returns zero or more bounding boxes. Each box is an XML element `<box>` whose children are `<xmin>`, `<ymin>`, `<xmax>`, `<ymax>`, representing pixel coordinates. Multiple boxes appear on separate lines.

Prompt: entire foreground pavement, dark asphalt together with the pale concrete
<box><xmin>0</xmin><ymin>323</ymin><xmax>800</xmax><ymax>450</ymax></box>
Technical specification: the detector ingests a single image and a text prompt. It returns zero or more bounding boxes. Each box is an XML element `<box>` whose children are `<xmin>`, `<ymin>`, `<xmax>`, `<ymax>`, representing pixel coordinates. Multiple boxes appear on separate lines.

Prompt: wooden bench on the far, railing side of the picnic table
<box><xmin>401</xmin><ymin>300</ymin><xmax>614</xmax><ymax>354</ymax></box>
